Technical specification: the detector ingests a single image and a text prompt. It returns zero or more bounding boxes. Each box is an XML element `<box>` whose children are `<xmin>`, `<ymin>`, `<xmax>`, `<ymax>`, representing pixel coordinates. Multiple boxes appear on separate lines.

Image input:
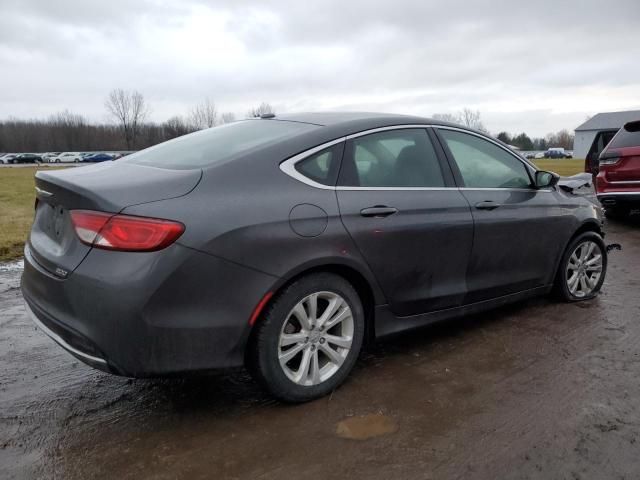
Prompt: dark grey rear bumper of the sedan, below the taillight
<box><xmin>21</xmin><ymin>244</ymin><xmax>276</xmax><ymax>377</ymax></box>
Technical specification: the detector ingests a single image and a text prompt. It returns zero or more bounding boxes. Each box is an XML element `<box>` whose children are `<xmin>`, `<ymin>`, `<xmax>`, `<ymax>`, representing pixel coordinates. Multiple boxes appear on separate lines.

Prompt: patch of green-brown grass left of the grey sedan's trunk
<box><xmin>0</xmin><ymin>167</ymin><xmax>65</xmax><ymax>261</ymax></box>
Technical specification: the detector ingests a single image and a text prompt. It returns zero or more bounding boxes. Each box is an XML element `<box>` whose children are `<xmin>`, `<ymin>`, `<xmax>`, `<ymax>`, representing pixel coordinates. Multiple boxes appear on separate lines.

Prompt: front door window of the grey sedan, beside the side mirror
<box><xmin>440</xmin><ymin>129</ymin><xmax>531</xmax><ymax>188</ymax></box>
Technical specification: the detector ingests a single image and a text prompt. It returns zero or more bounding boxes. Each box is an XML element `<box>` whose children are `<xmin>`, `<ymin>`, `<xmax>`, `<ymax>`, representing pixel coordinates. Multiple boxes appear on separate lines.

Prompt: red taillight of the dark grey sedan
<box><xmin>71</xmin><ymin>210</ymin><xmax>184</xmax><ymax>252</ymax></box>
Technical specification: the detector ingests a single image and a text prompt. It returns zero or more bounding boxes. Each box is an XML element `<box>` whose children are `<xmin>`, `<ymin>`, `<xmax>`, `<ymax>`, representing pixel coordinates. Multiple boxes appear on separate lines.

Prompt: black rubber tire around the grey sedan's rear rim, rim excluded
<box><xmin>254</xmin><ymin>273</ymin><xmax>365</xmax><ymax>402</ymax></box>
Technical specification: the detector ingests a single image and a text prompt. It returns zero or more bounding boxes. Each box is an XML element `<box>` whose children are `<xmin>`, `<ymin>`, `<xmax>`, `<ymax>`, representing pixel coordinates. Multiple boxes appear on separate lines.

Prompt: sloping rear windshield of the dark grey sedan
<box><xmin>118</xmin><ymin>120</ymin><xmax>318</xmax><ymax>169</ymax></box>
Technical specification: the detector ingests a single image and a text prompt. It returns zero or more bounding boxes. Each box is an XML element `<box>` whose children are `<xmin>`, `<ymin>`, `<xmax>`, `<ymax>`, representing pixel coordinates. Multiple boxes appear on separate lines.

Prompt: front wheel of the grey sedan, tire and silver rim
<box><xmin>554</xmin><ymin>232</ymin><xmax>607</xmax><ymax>302</ymax></box>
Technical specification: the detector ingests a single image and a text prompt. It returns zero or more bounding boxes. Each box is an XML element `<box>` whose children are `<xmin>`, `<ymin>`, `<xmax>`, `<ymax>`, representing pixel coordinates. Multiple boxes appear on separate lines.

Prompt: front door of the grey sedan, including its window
<box><xmin>437</xmin><ymin>127</ymin><xmax>572</xmax><ymax>303</ymax></box>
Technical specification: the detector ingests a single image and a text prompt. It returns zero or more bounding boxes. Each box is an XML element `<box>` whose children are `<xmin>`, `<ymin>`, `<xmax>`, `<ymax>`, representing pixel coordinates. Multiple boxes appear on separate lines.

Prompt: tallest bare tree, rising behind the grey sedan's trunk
<box><xmin>104</xmin><ymin>88</ymin><xmax>149</xmax><ymax>150</ymax></box>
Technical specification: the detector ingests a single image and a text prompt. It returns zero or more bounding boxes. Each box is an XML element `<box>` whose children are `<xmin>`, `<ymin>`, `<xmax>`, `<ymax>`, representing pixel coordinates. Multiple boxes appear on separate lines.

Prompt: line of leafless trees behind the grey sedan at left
<box><xmin>0</xmin><ymin>89</ymin><xmax>275</xmax><ymax>153</ymax></box>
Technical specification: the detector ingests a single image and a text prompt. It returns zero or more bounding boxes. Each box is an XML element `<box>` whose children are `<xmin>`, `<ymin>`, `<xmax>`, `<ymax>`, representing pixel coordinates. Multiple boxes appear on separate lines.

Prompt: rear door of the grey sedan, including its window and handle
<box><xmin>337</xmin><ymin>127</ymin><xmax>473</xmax><ymax>316</ymax></box>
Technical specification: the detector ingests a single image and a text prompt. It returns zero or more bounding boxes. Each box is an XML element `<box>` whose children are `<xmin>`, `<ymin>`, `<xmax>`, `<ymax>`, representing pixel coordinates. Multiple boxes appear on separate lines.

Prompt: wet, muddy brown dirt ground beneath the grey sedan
<box><xmin>0</xmin><ymin>216</ymin><xmax>640</xmax><ymax>480</ymax></box>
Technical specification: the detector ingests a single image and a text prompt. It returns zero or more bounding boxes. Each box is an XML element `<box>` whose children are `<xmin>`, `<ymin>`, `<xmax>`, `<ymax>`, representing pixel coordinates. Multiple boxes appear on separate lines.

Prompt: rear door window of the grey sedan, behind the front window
<box><xmin>340</xmin><ymin>129</ymin><xmax>444</xmax><ymax>187</ymax></box>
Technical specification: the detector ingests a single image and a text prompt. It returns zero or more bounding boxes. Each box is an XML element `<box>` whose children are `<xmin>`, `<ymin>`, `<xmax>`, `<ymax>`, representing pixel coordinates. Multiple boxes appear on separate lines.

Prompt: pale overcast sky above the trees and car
<box><xmin>0</xmin><ymin>0</ymin><xmax>640</xmax><ymax>136</ymax></box>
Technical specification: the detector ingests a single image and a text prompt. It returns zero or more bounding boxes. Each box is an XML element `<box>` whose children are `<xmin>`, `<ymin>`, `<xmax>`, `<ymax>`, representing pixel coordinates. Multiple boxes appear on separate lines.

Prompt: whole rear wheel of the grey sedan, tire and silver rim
<box><xmin>247</xmin><ymin>273</ymin><xmax>365</xmax><ymax>402</ymax></box>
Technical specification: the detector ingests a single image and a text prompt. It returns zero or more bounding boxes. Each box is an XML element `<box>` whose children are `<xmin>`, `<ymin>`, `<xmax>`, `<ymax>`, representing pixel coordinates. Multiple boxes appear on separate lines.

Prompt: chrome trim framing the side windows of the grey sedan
<box><xmin>280</xmin><ymin>124</ymin><xmax>552</xmax><ymax>192</ymax></box>
